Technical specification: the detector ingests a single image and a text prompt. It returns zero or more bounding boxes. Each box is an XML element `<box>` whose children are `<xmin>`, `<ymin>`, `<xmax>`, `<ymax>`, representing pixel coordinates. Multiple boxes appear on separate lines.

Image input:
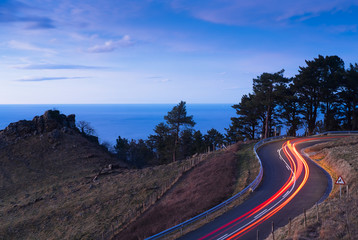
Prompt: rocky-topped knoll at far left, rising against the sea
<box><xmin>0</xmin><ymin>111</ymin><xmax>124</xmax><ymax>199</ymax></box>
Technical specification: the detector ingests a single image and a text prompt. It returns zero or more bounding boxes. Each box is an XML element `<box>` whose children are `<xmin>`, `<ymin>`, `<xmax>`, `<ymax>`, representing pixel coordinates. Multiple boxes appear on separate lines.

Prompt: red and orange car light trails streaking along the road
<box><xmin>200</xmin><ymin>137</ymin><xmax>328</xmax><ymax>240</ymax></box>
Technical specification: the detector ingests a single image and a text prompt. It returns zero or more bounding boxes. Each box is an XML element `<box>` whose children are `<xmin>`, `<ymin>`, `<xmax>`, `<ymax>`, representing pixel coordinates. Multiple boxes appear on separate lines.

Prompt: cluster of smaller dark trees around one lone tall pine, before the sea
<box><xmin>114</xmin><ymin>101</ymin><xmax>225</xmax><ymax>167</ymax></box>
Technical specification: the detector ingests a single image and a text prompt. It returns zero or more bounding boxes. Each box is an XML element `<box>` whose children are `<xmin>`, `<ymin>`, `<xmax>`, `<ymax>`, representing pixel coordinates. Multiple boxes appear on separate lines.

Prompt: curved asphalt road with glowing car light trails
<box><xmin>180</xmin><ymin>137</ymin><xmax>332</xmax><ymax>240</ymax></box>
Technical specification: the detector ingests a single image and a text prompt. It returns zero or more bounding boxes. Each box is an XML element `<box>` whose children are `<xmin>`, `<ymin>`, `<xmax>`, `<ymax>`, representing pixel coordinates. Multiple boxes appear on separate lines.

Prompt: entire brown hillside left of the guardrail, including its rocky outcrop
<box><xmin>0</xmin><ymin>111</ymin><xmax>258</xmax><ymax>239</ymax></box>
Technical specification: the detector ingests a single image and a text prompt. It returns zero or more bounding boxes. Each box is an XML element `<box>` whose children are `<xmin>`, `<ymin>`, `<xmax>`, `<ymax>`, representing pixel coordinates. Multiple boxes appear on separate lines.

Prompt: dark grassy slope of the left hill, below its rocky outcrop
<box><xmin>0</xmin><ymin>133</ymin><xmax>116</xmax><ymax>200</ymax></box>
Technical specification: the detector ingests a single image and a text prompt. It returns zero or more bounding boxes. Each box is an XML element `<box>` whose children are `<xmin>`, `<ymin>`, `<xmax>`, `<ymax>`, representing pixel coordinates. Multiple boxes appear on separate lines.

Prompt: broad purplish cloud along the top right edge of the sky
<box><xmin>171</xmin><ymin>0</ymin><xmax>357</xmax><ymax>26</ymax></box>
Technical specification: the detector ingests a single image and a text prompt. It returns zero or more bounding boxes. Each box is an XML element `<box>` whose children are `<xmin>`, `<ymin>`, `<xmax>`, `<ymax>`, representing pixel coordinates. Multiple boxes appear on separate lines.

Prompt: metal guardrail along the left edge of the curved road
<box><xmin>146</xmin><ymin>136</ymin><xmax>286</xmax><ymax>240</ymax></box>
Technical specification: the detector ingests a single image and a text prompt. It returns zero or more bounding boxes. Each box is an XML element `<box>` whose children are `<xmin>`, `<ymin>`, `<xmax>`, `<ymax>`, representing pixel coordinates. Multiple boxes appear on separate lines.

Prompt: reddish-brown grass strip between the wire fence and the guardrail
<box><xmin>115</xmin><ymin>144</ymin><xmax>259</xmax><ymax>239</ymax></box>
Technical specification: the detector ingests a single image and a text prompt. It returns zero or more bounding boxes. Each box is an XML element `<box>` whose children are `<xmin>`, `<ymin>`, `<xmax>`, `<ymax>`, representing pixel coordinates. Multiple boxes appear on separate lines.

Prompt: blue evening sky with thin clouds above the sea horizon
<box><xmin>0</xmin><ymin>0</ymin><xmax>358</xmax><ymax>104</ymax></box>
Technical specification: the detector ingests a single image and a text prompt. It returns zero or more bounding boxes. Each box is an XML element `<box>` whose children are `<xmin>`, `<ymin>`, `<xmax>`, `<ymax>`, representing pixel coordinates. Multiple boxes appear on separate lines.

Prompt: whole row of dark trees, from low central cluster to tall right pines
<box><xmin>114</xmin><ymin>55</ymin><xmax>358</xmax><ymax>167</ymax></box>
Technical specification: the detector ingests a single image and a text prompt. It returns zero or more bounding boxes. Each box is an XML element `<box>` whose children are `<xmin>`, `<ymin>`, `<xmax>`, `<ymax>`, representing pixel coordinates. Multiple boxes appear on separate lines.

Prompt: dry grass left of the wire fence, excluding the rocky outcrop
<box><xmin>0</xmin><ymin>131</ymin><xmax>206</xmax><ymax>239</ymax></box>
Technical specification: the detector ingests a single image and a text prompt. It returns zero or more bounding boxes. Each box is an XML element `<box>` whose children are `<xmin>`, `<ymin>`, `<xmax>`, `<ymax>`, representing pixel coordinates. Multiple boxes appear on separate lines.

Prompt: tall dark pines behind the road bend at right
<box><xmin>226</xmin><ymin>55</ymin><xmax>358</xmax><ymax>142</ymax></box>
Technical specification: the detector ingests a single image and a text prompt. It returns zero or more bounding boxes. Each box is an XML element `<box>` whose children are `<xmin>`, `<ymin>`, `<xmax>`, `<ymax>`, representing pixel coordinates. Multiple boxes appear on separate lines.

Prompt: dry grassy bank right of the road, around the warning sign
<box><xmin>267</xmin><ymin>137</ymin><xmax>358</xmax><ymax>239</ymax></box>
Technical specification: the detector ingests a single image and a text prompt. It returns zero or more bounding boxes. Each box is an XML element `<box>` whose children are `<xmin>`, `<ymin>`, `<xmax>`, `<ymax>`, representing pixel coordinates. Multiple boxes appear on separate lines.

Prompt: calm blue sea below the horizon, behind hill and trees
<box><xmin>0</xmin><ymin>104</ymin><xmax>235</xmax><ymax>145</ymax></box>
